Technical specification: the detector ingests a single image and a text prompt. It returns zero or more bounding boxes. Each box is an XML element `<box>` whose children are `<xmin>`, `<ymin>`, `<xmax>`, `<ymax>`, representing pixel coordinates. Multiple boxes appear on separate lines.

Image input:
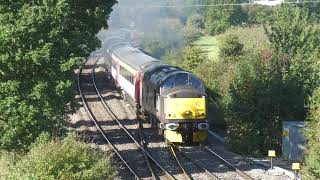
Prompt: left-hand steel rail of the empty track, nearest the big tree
<box><xmin>77</xmin><ymin>68</ymin><xmax>141</xmax><ymax>180</ymax></box>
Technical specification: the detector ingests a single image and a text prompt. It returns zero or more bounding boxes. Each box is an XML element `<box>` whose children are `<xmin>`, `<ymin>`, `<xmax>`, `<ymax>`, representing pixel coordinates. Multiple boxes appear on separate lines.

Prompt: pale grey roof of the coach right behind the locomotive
<box><xmin>111</xmin><ymin>45</ymin><xmax>161</xmax><ymax>70</ymax></box>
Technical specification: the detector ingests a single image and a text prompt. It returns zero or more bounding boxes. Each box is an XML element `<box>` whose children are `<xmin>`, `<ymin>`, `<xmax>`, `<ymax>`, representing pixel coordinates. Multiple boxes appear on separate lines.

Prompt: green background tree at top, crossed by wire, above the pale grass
<box><xmin>206</xmin><ymin>0</ymin><xmax>244</xmax><ymax>35</ymax></box>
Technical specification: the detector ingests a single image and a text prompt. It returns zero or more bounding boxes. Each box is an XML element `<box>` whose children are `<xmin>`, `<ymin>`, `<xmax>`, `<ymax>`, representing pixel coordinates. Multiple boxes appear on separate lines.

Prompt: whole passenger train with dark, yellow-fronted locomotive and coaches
<box><xmin>102</xmin><ymin>29</ymin><xmax>209</xmax><ymax>143</ymax></box>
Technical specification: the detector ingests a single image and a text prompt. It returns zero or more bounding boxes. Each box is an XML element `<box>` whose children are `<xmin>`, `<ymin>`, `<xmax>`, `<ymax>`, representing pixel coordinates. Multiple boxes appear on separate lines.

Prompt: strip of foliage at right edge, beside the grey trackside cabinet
<box><xmin>302</xmin><ymin>88</ymin><xmax>320</xmax><ymax>180</ymax></box>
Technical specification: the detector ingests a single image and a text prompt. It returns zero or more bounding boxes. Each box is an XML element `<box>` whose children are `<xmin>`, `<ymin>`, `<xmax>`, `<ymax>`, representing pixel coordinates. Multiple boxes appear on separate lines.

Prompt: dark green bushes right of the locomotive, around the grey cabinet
<box><xmin>226</xmin><ymin>49</ymin><xmax>319</xmax><ymax>155</ymax></box>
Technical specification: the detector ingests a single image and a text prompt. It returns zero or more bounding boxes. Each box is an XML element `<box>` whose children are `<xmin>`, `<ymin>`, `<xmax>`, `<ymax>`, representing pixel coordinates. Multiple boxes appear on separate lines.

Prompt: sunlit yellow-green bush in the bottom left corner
<box><xmin>0</xmin><ymin>134</ymin><xmax>116</xmax><ymax>180</ymax></box>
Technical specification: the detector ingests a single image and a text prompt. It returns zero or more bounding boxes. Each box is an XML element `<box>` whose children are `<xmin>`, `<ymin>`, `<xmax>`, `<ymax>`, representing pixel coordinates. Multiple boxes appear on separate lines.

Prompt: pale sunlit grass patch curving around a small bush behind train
<box><xmin>194</xmin><ymin>26</ymin><xmax>270</xmax><ymax>61</ymax></box>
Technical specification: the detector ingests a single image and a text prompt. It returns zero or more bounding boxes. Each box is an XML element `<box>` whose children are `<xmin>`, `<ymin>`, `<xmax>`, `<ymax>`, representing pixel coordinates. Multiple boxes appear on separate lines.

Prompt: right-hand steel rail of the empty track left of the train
<box><xmin>91</xmin><ymin>62</ymin><xmax>176</xmax><ymax>180</ymax></box>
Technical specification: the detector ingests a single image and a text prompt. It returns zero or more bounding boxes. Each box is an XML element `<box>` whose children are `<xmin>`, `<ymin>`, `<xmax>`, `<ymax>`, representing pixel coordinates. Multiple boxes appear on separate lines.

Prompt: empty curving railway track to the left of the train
<box><xmin>78</xmin><ymin>58</ymin><xmax>174</xmax><ymax>179</ymax></box>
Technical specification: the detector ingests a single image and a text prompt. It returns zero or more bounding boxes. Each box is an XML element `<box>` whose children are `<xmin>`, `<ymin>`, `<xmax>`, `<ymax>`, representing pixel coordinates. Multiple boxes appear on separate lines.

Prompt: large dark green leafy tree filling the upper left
<box><xmin>0</xmin><ymin>0</ymin><xmax>116</xmax><ymax>150</ymax></box>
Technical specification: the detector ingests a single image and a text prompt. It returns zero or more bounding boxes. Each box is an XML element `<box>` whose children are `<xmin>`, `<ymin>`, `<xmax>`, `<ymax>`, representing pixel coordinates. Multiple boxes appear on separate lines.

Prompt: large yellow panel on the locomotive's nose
<box><xmin>164</xmin><ymin>98</ymin><xmax>207</xmax><ymax>119</ymax></box>
